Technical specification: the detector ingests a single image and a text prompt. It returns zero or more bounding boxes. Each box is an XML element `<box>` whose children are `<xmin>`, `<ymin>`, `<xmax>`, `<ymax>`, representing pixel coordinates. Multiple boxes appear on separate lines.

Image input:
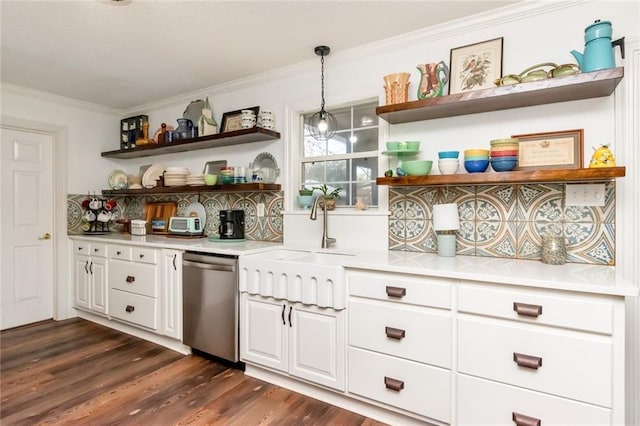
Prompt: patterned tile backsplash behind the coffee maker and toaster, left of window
<box><xmin>67</xmin><ymin>191</ymin><xmax>283</xmax><ymax>242</ymax></box>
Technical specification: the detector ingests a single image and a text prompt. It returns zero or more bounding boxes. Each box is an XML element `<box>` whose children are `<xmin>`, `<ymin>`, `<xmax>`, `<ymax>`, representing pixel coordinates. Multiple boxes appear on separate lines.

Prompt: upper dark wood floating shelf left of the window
<box><xmin>102</xmin><ymin>127</ymin><xmax>280</xmax><ymax>159</ymax></box>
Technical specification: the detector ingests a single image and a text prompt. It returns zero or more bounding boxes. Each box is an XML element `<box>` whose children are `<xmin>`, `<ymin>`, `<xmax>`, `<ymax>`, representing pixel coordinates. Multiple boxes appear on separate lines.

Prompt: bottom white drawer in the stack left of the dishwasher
<box><xmin>109</xmin><ymin>289</ymin><xmax>158</xmax><ymax>330</ymax></box>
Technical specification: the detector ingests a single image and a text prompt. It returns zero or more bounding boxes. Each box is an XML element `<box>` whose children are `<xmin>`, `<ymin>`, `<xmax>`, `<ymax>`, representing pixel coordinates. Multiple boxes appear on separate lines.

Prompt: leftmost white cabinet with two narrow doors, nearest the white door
<box><xmin>73</xmin><ymin>241</ymin><xmax>108</xmax><ymax>315</ymax></box>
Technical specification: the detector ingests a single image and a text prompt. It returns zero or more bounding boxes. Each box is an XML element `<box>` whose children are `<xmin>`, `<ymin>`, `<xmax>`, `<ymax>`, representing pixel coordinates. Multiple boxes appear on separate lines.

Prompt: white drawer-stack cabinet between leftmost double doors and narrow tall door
<box><xmin>109</xmin><ymin>245</ymin><xmax>160</xmax><ymax>332</ymax></box>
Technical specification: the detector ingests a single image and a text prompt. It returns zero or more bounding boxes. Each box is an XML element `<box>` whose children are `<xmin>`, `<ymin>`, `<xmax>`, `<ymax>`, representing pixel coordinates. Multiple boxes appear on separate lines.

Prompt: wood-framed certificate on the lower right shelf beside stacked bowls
<box><xmin>511</xmin><ymin>129</ymin><xmax>584</xmax><ymax>170</ymax></box>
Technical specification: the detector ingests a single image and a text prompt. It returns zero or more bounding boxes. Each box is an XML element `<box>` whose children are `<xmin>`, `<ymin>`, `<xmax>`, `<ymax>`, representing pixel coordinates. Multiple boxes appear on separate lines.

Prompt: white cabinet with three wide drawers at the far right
<box><xmin>456</xmin><ymin>282</ymin><xmax>625</xmax><ymax>425</ymax></box>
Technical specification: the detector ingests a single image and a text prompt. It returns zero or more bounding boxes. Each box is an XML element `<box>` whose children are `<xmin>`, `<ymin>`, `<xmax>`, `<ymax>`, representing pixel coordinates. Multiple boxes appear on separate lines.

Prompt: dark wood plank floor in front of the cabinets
<box><xmin>0</xmin><ymin>318</ymin><xmax>380</xmax><ymax>426</ymax></box>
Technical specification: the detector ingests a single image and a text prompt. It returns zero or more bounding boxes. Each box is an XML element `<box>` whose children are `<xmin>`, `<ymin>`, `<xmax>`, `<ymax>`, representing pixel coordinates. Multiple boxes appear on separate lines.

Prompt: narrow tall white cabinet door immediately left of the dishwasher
<box><xmin>160</xmin><ymin>249</ymin><xmax>182</xmax><ymax>340</ymax></box>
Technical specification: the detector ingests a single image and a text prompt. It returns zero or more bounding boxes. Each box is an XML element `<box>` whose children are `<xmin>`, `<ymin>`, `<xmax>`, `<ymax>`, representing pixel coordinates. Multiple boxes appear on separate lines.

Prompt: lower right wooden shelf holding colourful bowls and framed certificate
<box><xmin>376</xmin><ymin>167</ymin><xmax>626</xmax><ymax>186</ymax></box>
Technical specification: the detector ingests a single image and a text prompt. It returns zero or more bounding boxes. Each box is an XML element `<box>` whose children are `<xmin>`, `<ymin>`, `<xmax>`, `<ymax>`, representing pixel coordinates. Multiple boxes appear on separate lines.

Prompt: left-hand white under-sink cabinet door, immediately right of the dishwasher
<box><xmin>240</xmin><ymin>293</ymin><xmax>288</xmax><ymax>372</ymax></box>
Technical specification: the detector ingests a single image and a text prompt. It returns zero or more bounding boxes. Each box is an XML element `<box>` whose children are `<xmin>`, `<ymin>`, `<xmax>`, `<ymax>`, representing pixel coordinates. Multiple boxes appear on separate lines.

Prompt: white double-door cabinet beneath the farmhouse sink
<box><xmin>240</xmin><ymin>293</ymin><xmax>345</xmax><ymax>390</ymax></box>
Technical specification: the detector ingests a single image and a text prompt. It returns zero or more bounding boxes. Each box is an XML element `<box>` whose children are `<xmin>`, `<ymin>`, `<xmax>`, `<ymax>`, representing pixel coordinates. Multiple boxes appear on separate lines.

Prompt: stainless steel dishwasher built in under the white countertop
<box><xmin>182</xmin><ymin>252</ymin><xmax>239</xmax><ymax>362</ymax></box>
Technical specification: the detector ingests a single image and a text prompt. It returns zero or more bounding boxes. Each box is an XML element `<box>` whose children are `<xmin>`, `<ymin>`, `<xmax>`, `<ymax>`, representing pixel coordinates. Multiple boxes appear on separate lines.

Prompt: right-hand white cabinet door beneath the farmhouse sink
<box><xmin>287</xmin><ymin>304</ymin><xmax>345</xmax><ymax>391</ymax></box>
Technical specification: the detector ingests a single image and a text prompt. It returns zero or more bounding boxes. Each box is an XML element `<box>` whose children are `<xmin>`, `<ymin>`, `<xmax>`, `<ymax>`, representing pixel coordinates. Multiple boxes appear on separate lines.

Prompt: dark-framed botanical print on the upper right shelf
<box><xmin>449</xmin><ymin>37</ymin><xmax>503</xmax><ymax>95</ymax></box>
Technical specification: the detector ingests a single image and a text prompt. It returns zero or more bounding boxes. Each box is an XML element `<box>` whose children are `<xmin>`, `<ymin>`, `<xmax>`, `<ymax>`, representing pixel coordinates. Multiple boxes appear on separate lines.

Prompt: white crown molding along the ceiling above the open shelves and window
<box><xmin>122</xmin><ymin>0</ymin><xmax>597</xmax><ymax>115</ymax></box>
